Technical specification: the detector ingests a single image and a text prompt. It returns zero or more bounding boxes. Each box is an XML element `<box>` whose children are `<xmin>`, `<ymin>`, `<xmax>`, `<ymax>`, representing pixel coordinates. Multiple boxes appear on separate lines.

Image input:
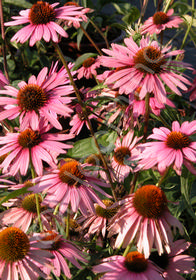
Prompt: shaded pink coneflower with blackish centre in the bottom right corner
<box><xmin>149</xmin><ymin>239</ymin><xmax>195</xmax><ymax>280</ymax></box>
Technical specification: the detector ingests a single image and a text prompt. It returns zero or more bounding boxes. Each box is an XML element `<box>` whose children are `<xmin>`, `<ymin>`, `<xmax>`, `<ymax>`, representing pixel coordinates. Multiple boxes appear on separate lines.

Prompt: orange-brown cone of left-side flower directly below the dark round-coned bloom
<box><xmin>18</xmin><ymin>128</ymin><xmax>42</xmax><ymax>149</ymax></box>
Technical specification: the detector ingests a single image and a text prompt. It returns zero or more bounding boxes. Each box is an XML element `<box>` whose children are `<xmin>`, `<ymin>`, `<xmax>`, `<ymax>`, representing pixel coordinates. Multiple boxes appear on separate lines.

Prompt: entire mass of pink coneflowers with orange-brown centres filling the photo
<box><xmin>0</xmin><ymin>1</ymin><xmax>196</xmax><ymax>280</ymax></box>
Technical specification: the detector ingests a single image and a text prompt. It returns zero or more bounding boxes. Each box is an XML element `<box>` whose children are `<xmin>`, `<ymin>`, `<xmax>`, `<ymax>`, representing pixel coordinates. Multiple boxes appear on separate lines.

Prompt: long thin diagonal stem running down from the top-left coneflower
<box><xmin>53</xmin><ymin>43</ymin><xmax>117</xmax><ymax>201</ymax></box>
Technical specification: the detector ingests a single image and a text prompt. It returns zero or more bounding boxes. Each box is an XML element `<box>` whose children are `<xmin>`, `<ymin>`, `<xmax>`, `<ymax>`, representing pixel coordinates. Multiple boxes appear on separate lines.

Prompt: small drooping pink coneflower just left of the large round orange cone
<box><xmin>78</xmin><ymin>199</ymin><xmax>118</xmax><ymax>240</ymax></box>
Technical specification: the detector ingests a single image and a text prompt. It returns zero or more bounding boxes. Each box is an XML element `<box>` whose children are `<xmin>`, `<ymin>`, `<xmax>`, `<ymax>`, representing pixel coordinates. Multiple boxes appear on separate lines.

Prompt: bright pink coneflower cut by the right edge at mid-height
<box><xmin>138</xmin><ymin>121</ymin><xmax>196</xmax><ymax>175</ymax></box>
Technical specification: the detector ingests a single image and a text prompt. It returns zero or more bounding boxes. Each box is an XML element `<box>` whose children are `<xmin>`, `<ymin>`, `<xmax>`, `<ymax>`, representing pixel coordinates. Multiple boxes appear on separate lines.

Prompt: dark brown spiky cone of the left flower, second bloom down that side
<box><xmin>17</xmin><ymin>84</ymin><xmax>48</xmax><ymax>113</ymax></box>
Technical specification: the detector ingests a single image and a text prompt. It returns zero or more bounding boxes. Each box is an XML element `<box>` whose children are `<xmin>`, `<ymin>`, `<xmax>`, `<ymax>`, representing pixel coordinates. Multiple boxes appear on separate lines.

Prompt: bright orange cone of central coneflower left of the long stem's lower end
<box><xmin>59</xmin><ymin>160</ymin><xmax>85</xmax><ymax>186</ymax></box>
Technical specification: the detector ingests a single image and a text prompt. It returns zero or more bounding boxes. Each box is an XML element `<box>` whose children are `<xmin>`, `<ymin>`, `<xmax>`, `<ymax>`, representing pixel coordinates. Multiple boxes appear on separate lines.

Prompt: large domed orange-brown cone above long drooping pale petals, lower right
<box><xmin>133</xmin><ymin>185</ymin><xmax>167</xmax><ymax>219</ymax></box>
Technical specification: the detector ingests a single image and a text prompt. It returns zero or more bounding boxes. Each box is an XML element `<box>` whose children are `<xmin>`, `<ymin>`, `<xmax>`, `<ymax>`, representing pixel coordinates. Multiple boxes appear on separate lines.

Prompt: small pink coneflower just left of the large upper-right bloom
<box><xmin>77</xmin><ymin>57</ymin><xmax>100</xmax><ymax>79</ymax></box>
